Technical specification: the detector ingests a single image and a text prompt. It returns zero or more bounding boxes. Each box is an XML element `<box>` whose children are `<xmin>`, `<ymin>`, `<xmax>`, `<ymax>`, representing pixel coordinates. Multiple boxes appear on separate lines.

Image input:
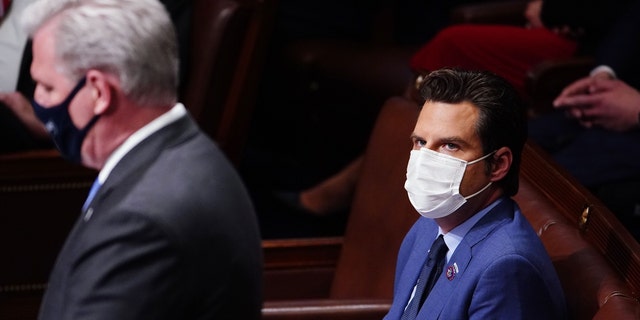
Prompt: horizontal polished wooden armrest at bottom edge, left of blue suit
<box><xmin>262</xmin><ymin>299</ymin><xmax>391</xmax><ymax>320</ymax></box>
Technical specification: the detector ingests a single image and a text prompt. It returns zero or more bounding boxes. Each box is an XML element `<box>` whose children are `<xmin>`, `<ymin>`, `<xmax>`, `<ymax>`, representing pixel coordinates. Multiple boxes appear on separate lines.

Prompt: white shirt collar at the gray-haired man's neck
<box><xmin>98</xmin><ymin>103</ymin><xmax>187</xmax><ymax>184</ymax></box>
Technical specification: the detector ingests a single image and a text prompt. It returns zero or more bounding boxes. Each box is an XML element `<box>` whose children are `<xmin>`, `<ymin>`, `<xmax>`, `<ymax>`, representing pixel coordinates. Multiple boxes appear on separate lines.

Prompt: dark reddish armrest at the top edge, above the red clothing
<box><xmin>451</xmin><ymin>0</ymin><xmax>527</xmax><ymax>26</ymax></box>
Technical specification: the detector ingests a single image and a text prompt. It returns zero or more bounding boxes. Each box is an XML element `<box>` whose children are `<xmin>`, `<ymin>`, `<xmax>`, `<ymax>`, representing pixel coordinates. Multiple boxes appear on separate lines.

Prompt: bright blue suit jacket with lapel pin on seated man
<box><xmin>385</xmin><ymin>198</ymin><xmax>567</xmax><ymax>320</ymax></box>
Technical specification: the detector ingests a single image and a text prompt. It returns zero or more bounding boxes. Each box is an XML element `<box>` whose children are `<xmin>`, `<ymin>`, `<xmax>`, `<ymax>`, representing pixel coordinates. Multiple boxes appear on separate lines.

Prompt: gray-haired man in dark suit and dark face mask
<box><xmin>23</xmin><ymin>0</ymin><xmax>262</xmax><ymax>320</ymax></box>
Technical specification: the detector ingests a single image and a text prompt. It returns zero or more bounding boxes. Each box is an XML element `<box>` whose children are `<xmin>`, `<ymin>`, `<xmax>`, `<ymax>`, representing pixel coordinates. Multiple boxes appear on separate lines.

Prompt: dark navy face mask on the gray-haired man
<box><xmin>31</xmin><ymin>77</ymin><xmax>99</xmax><ymax>163</ymax></box>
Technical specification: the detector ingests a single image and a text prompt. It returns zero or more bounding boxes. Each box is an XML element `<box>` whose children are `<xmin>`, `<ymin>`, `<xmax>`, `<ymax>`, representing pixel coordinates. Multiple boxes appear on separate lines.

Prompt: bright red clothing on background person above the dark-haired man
<box><xmin>411</xmin><ymin>24</ymin><xmax>577</xmax><ymax>93</ymax></box>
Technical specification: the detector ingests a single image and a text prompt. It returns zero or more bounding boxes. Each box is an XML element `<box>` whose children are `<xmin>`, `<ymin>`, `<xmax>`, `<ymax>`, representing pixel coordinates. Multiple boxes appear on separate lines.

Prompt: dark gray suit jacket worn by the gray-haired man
<box><xmin>40</xmin><ymin>117</ymin><xmax>262</xmax><ymax>320</ymax></box>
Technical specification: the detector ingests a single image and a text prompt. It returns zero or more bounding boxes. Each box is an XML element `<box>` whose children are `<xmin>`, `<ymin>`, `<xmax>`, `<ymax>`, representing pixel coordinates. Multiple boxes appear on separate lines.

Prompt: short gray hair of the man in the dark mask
<box><xmin>22</xmin><ymin>0</ymin><xmax>179</xmax><ymax>105</ymax></box>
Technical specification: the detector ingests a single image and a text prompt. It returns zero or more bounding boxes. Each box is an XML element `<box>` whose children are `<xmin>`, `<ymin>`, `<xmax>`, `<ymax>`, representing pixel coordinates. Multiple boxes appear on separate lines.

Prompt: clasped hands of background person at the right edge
<box><xmin>553</xmin><ymin>74</ymin><xmax>640</xmax><ymax>131</ymax></box>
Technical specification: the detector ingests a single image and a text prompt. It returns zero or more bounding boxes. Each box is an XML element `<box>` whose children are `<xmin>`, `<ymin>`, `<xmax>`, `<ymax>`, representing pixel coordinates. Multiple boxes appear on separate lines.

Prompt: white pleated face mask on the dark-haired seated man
<box><xmin>404</xmin><ymin>148</ymin><xmax>495</xmax><ymax>219</ymax></box>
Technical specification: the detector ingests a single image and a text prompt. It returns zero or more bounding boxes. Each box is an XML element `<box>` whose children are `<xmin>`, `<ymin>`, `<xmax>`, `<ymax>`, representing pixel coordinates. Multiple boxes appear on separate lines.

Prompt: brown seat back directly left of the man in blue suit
<box><xmin>331</xmin><ymin>98</ymin><xmax>418</xmax><ymax>299</ymax></box>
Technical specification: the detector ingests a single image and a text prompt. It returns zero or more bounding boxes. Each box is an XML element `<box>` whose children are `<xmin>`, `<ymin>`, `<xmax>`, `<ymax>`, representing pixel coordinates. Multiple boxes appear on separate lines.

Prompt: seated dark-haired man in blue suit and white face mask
<box><xmin>385</xmin><ymin>69</ymin><xmax>567</xmax><ymax>320</ymax></box>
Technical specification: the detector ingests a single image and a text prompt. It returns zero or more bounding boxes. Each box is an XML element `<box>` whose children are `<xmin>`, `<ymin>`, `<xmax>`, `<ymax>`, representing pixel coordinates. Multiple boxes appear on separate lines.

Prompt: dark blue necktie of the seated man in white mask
<box><xmin>401</xmin><ymin>235</ymin><xmax>449</xmax><ymax>320</ymax></box>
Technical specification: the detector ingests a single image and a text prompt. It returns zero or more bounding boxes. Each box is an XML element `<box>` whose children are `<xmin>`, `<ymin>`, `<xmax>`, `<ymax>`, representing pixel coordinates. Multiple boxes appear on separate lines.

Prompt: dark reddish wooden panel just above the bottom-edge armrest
<box><xmin>262</xmin><ymin>237</ymin><xmax>342</xmax><ymax>301</ymax></box>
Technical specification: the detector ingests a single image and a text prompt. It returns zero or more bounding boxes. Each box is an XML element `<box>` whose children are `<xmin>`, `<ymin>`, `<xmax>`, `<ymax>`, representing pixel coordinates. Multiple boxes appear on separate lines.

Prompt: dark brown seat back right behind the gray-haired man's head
<box><xmin>181</xmin><ymin>0</ymin><xmax>275</xmax><ymax>164</ymax></box>
